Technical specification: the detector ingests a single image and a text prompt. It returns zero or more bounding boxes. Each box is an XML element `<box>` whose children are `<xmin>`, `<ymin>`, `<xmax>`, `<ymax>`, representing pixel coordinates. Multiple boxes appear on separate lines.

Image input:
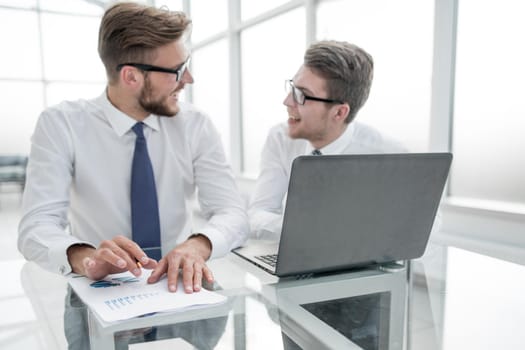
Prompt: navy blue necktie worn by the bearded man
<box><xmin>131</xmin><ymin>123</ymin><xmax>162</xmax><ymax>260</ymax></box>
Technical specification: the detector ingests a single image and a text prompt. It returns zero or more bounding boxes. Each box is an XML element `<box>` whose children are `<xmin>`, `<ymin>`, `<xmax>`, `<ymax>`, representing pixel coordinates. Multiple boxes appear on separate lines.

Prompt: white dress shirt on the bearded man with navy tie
<box><xmin>18</xmin><ymin>93</ymin><xmax>249</xmax><ymax>274</ymax></box>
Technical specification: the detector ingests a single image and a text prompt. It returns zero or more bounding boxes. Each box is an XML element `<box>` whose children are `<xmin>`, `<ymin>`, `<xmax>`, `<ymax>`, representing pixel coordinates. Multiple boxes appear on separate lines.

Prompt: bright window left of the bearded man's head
<box><xmin>0</xmin><ymin>0</ymin><xmax>106</xmax><ymax>154</ymax></box>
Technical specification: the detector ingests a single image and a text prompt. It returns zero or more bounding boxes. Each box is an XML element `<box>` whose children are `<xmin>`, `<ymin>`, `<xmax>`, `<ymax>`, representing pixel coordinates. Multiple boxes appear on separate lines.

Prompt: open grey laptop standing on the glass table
<box><xmin>233</xmin><ymin>153</ymin><xmax>452</xmax><ymax>276</ymax></box>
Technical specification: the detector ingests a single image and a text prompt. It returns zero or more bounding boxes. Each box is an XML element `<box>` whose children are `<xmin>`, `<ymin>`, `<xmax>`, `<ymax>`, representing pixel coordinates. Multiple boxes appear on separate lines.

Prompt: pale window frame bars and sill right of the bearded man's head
<box><xmin>188</xmin><ymin>0</ymin><xmax>525</xmax><ymax>263</ymax></box>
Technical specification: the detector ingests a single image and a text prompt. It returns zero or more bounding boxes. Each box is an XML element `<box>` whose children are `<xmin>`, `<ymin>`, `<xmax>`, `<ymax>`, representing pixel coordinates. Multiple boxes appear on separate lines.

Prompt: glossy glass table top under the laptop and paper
<box><xmin>7</xmin><ymin>244</ymin><xmax>525</xmax><ymax>349</ymax></box>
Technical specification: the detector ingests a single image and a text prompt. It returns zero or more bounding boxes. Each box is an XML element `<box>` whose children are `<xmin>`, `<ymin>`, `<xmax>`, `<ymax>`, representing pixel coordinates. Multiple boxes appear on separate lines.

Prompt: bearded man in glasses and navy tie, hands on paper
<box><xmin>18</xmin><ymin>3</ymin><xmax>248</xmax><ymax>293</ymax></box>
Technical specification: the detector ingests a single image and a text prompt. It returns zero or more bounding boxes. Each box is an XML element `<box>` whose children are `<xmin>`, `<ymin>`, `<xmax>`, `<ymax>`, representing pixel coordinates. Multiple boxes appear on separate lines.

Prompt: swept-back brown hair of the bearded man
<box><xmin>98</xmin><ymin>2</ymin><xmax>191</xmax><ymax>83</ymax></box>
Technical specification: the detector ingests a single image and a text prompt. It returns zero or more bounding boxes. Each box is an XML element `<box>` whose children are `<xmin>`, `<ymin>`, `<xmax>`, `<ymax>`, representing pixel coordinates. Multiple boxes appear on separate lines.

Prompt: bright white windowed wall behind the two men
<box><xmin>0</xmin><ymin>0</ymin><xmax>525</xmax><ymax>246</ymax></box>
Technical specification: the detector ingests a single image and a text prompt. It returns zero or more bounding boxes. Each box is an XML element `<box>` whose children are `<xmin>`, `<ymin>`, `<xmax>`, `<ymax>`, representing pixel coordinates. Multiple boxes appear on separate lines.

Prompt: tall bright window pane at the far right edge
<box><xmin>450</xmin><ymin>0</ymin><xmax>525</xmax><ymax>205</ymax></box>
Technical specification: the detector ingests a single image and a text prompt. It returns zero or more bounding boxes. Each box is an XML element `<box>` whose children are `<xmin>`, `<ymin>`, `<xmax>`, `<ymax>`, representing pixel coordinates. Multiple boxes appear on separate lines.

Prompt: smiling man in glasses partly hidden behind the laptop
<box><xmin>248</xmin><ymin>41</ymin><xmax>406</xmax><ymax>239</ymax></box>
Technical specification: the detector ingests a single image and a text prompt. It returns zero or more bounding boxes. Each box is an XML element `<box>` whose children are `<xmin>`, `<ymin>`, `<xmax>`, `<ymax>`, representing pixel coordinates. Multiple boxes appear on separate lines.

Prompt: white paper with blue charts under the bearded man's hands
<box><xmin>69</xmin><ymin>270</ymin><xmax>227</xmax><ymax>322</ymax></box>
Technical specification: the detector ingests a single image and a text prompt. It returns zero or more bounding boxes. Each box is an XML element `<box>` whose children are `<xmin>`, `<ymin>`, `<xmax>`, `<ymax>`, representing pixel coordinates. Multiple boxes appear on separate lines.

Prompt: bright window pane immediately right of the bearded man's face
<box><xmin>191</xmin><ymin>39</ymin><xmax>230</xmax><ymax>157</ymax></box>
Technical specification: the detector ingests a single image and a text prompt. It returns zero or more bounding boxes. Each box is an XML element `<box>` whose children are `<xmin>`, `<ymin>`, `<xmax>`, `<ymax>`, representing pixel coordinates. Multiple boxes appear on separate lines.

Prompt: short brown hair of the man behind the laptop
<box><xmin>304</xmin><ymin>40</ymin><xmax>374</xmax><ymax>123</ymax></box>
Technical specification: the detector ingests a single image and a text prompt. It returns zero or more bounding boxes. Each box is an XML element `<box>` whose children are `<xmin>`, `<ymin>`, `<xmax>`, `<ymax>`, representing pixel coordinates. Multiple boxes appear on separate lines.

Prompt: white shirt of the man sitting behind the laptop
<box><xmin>248</xmin><ymin>122</ymin><xmax>407</xmax><ymax>240</ymax></box>
